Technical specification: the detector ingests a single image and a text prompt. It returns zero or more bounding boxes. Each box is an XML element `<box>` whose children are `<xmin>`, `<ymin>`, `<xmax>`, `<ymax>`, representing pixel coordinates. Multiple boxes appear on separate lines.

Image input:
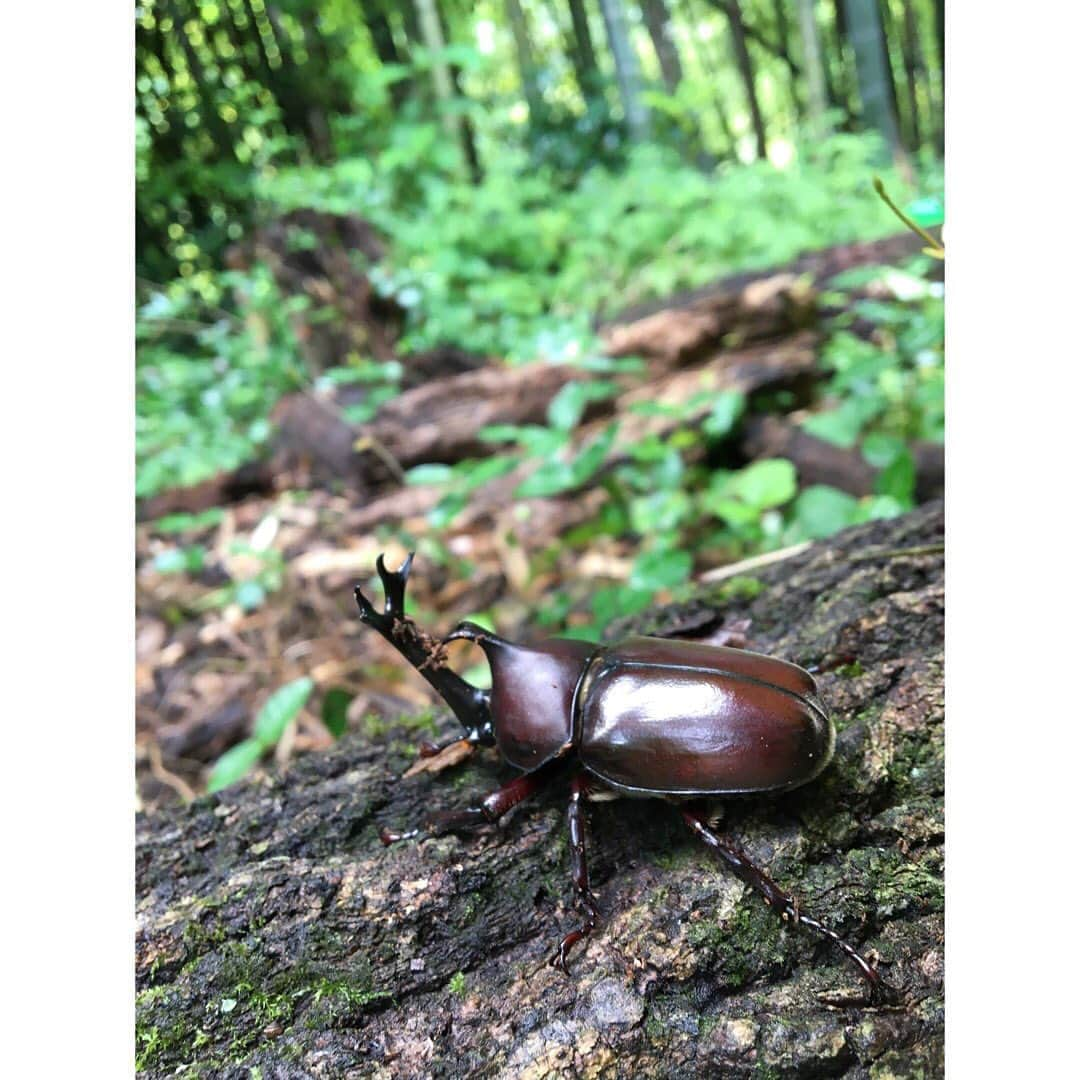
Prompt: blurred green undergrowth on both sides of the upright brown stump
<box><xmin>136</xmin><ymin>135</ymin><xmax>940</xmax><ymax>496</ymax></box>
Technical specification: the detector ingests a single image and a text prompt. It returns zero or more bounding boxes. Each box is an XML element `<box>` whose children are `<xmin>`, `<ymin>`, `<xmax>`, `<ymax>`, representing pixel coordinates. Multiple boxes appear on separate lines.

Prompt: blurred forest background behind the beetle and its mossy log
<box><xmin>135</xmin><ymin>0</ymin><xmax>944</xmax><ymax>807</ymax></box>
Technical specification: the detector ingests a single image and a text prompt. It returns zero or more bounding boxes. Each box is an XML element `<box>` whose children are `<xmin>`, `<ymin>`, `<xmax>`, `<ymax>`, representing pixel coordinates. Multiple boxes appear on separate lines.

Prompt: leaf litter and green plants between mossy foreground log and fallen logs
<box><xmin>137</xmin><ymin>247</ymin><xmax>943</xmax><ymax>806</ymax></box>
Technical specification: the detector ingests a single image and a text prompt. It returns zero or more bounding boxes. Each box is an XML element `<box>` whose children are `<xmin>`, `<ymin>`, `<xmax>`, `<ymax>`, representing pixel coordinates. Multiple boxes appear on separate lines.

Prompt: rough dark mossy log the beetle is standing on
<box><xmin>136</xmin><ymin>503</ymin><xmax>944</xmax><ymax>1080</ymax></box>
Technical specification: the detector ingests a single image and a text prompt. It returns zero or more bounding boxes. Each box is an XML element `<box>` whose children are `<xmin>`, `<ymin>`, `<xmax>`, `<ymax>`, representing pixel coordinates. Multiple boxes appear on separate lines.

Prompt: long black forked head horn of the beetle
<box><xmin>355</xmin><ymin>552</ymin><xmax>495</xmax><ymax>746</ymax></box>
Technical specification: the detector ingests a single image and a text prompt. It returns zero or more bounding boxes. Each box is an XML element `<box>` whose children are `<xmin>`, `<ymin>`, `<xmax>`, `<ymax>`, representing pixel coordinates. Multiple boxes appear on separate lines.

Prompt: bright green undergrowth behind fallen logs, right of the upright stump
<box><xmin>261</xmin><ymin>135</ymin><xmax>935</xmax><ymax>361</ymax></box>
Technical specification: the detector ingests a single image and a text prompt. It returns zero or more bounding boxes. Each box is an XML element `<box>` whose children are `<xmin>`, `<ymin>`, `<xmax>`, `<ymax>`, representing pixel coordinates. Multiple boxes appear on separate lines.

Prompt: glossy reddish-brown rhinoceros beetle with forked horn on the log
<box><xmin>355</xmin><ymin>554</ymin><xmax>890</xmax><ymax>997</ymax></box>
